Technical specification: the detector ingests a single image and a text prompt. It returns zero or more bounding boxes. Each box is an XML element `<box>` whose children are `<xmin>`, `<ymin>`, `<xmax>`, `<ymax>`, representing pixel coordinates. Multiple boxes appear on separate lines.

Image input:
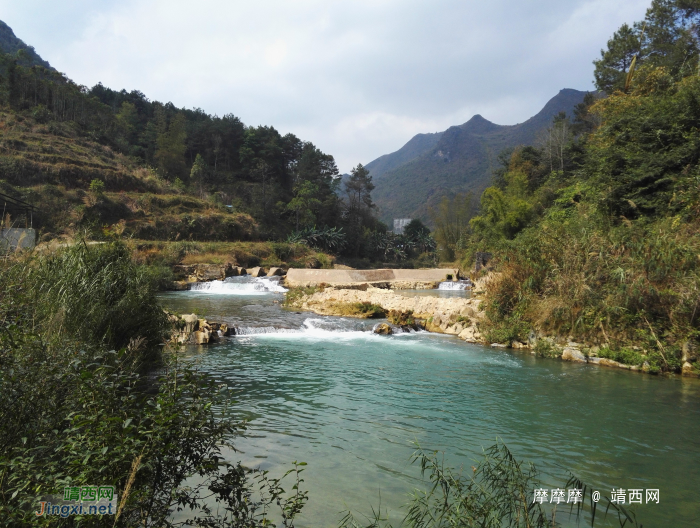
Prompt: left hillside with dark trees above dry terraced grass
<box><xmin>0</xmin><ymin>24</ymin><xmax>408</xmax><ymax>258</ymax></box>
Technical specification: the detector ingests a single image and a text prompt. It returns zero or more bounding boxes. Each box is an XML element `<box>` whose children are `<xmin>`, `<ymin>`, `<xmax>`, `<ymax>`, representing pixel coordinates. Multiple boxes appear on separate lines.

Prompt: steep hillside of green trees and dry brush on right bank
<box><xmin>446</xmin><ymin>0</ymin><xmax>700</xmax><ymax>374</ymax></box>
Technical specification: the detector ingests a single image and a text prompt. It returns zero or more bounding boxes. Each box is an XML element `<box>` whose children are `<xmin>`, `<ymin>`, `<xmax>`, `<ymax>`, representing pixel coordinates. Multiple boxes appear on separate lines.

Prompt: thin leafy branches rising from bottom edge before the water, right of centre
<box><xmin>340</xmin><ymin>443</ymin><xmax>641</xmax><ymax>528</ymax></box>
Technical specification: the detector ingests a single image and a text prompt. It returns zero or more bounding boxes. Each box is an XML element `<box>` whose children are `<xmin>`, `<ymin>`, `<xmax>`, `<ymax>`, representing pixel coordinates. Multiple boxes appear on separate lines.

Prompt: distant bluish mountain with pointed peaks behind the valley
<box><xmin>366</xmin><ymin>88</ymin><xmax>586</xmax><ymax>225</ymax></box>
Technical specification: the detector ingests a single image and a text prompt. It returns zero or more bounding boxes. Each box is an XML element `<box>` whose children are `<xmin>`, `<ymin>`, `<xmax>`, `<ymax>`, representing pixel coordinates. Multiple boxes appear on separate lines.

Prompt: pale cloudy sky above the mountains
<box><xmin>0</xmin><ymin>0</ymin><xmax>651</xmax><ymax>172</ymax></box>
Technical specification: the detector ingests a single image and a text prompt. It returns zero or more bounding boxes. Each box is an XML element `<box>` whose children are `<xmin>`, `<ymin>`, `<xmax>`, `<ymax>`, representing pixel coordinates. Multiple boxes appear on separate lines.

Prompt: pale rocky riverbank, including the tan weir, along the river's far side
<box><xmin>160</xmin><ymin>263</ymin><xmax>699</xmax><ymax>377</ymax></box>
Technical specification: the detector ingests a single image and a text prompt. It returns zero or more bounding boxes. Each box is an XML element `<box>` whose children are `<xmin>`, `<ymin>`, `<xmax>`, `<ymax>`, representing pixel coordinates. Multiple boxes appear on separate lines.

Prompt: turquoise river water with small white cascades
<box><xmin>161</xmin><ymin>283</ymin><xmax>700</xmax><ymax>527</ymax></box>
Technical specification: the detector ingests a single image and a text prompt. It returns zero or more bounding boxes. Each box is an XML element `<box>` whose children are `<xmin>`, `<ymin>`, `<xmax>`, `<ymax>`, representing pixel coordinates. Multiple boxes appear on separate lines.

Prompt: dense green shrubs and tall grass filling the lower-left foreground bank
<box><xmin>0</xmin><ymin>246</ymin><xmax>307</xmax><ymax>527</ymax></box>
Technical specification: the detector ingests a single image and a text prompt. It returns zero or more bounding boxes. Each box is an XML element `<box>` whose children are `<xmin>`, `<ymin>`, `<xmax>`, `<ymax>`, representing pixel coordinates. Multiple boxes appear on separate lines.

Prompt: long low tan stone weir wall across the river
<box><xmin>285</xmin><ymin>268</ymin><xmax>459</xmax><ymax>290</ymax></box>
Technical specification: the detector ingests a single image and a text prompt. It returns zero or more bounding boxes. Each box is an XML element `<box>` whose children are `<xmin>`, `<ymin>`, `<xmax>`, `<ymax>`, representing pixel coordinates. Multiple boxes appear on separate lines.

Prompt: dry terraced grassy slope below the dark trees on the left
<box><xmin>0</xmin><ymin>110</ymin><xmax>256</xmax><ymax>240</ymax></box>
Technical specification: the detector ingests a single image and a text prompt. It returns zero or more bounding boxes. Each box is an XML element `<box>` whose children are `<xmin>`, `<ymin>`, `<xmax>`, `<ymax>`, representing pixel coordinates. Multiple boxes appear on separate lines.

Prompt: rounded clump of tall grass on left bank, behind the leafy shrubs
<box><xmin>26</xmin><ymin>241</ymin><xmax>167</xmax><ymax>348</ymax></box>
